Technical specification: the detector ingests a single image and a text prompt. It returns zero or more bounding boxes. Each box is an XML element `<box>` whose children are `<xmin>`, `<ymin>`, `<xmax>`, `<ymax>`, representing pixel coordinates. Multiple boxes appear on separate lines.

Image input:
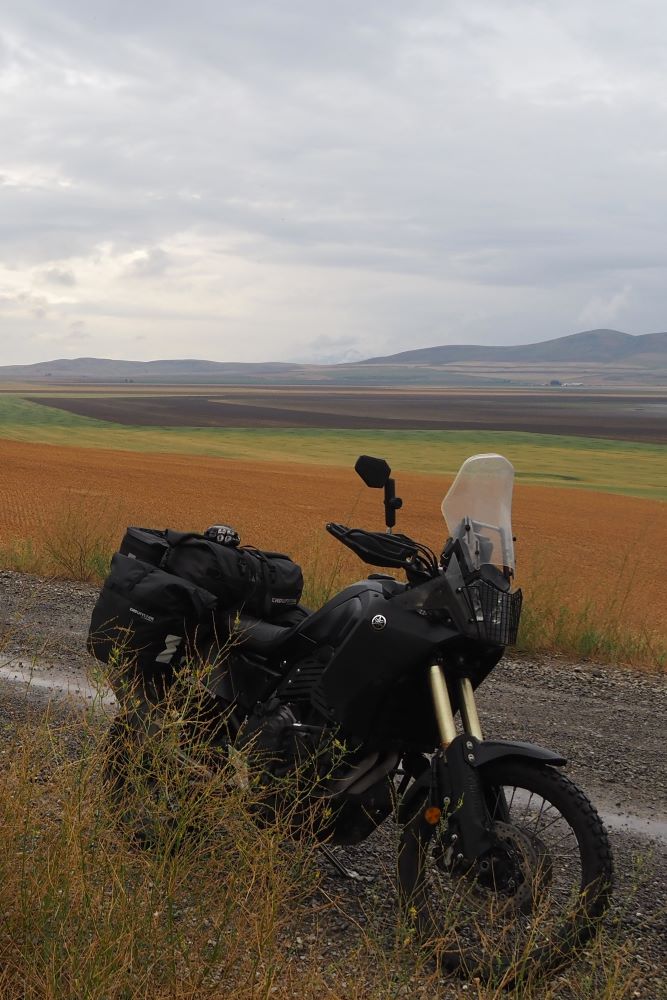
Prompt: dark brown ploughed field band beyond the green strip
<box><xmin>13</xmin><ymin>387</ymin><xmax>667</xmax><ymax>444</ymax></box>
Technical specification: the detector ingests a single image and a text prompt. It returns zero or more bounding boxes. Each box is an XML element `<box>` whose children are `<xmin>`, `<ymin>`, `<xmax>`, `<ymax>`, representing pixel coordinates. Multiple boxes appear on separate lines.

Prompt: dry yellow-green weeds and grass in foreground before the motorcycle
<box><xmin>0</xmin><ymin>672</ymin><xmax>637</xmax><ymax>1000</ymax></box>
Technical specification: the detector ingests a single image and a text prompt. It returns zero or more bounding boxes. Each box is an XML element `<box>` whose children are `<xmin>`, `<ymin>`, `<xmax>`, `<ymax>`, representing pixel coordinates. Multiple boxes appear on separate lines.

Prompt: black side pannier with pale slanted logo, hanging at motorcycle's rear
<box><xmin>88</xmin><ymin>552</ymin><xmax>216</xmax><ymax>680</ymax></box>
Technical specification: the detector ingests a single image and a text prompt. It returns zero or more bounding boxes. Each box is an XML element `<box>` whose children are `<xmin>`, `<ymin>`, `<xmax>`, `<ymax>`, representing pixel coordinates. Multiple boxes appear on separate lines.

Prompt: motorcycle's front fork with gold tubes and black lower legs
<box><xmin>424</xmin><ymin>663</ymin><xmax>491</xmax><ymax>861</ymax></box>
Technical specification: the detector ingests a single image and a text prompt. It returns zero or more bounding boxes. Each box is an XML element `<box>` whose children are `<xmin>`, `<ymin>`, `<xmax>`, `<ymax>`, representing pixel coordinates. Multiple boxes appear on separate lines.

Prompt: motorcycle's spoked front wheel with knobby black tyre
<box><xmin>399</xmin><ymin>759</ymin><xmax>612</xmax><ymax>985</ymax></box>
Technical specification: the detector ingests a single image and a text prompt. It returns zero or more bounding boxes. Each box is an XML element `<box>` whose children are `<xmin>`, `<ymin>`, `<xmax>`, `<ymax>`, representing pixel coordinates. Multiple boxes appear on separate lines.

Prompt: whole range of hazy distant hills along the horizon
<box><xmin>0</xmin><ymin>330</ymin><xmax>667</xmax><ymax>387</ymax></box>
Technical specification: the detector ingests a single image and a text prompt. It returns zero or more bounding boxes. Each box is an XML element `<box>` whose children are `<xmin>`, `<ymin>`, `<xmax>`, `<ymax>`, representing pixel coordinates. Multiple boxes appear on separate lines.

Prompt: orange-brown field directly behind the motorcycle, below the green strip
<box><xmin>0</xmin><ymin>440</ymin><xmax>667</xmax><ymax>635</ymax></box>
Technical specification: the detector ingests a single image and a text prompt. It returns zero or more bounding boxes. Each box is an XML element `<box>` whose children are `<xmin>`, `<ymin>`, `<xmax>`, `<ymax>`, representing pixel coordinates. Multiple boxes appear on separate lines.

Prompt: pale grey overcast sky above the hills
<box><xmin>0</xmin><ymin>0</ymin><xmax>667</xmax><ymax>364</ymax></box>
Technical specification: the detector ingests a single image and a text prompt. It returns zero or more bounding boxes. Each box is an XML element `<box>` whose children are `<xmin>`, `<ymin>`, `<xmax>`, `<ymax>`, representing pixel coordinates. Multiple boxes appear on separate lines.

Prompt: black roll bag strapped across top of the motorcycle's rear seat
<box><xmin>162</xmin><ymin>531</ymin><xmax>303</xmax><ymax>620</ymax></box>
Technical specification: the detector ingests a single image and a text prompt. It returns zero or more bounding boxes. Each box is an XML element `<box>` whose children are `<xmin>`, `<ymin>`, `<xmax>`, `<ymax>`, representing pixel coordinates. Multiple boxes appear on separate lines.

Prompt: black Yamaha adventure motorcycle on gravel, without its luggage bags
<box><xmin>91</xmin><ymin>454</ymin><xmax>612</xmax><ymax>971</ymax></box>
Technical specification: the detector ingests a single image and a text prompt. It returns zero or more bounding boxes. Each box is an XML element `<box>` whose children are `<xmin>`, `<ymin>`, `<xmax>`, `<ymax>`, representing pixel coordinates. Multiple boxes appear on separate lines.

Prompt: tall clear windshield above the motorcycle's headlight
<box><xmin>442</xmin><ymin>454</ymin><xmax>514</xmax><ymax>572</ymax></box>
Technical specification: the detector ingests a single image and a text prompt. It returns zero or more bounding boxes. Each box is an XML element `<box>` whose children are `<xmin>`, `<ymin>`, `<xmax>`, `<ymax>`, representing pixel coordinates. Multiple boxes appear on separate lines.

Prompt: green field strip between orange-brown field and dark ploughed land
<box><xmin>0</xmin><ymin>395</ymin><xmax>667</xmax><ymax>500</ymax></box>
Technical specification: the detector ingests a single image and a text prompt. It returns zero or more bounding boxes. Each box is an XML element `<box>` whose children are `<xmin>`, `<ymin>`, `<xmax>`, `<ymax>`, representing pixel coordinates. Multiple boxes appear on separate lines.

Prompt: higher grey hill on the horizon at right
<box><xmin>363</xmin><ymin>330</ymin><xmax>667</xmax><ymax>365</ymax></box>
